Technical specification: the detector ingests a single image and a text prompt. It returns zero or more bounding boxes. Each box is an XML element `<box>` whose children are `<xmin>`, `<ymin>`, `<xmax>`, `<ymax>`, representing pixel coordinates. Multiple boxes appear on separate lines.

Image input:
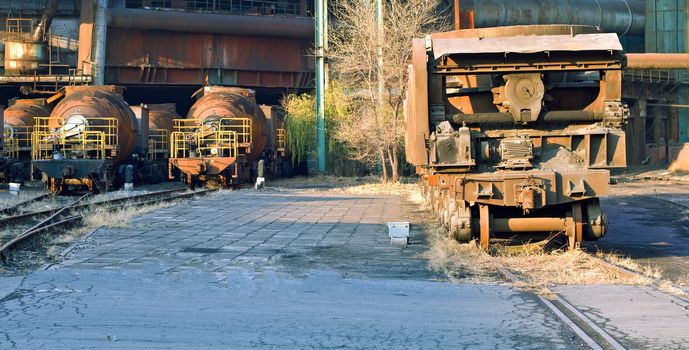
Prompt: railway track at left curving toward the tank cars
<box><xmin>0</xmin><ymin>189</ymin><xmax>214</xmax><ymax>260</ymax></box>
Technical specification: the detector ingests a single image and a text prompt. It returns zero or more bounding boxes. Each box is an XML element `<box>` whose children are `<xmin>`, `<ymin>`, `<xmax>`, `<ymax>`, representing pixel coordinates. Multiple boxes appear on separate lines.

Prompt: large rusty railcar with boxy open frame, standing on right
<box><xmin>405</xmin><ymin>25</ymin><xmax>628</xmax><ymax>248</ymax></box>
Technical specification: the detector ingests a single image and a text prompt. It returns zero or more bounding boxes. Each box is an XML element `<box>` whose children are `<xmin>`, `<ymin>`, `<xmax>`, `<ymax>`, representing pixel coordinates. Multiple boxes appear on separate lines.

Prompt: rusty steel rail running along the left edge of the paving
<box><xmin>0</xmin><ymin>189</ymin><xmax>215</xmax><ymax>260</ymax></box>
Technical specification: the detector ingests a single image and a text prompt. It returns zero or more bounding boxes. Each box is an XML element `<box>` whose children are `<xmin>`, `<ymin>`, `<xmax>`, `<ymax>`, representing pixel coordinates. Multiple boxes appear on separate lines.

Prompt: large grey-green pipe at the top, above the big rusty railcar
<box><xmin>459</xmin><ymin>0</ymin><xmax>646</xmax><ymax>35</ymax></box>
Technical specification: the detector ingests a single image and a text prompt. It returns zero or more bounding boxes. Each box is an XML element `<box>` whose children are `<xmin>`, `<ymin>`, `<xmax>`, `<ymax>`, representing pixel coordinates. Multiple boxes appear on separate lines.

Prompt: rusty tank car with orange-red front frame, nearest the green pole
<box><xmin>170</xmin><ymin>86</ymin><xmax>286</xmax><ymax>187</ymax></box>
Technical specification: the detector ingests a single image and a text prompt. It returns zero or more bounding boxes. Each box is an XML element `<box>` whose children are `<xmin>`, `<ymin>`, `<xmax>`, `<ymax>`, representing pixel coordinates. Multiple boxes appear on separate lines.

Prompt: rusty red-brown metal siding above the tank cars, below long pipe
<box><xmin>106</xmin><ymin>28</ymin><xmax>313</xmax><ymax>88</ymax></box>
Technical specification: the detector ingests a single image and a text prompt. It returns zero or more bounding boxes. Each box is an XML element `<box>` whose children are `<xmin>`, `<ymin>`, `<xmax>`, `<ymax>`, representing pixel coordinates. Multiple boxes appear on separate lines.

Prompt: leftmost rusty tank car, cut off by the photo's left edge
<box><xmin>0</xmin><ymin>99</ymin><xmax>50</xmax><ymax>183</ymax></box>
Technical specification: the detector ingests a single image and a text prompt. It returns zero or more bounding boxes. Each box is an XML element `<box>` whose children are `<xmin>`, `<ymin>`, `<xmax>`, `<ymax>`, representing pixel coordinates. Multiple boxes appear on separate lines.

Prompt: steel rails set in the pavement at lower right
<box><xmin>497</xmin><ymin>266</ymin><xmax>626</xmax><ymax>350</ymax></box>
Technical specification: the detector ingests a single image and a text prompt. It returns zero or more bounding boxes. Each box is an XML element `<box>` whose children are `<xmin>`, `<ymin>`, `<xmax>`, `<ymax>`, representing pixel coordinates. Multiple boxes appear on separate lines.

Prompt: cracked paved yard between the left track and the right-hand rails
<box><xmin>0</xmin><ymin>191</ymin><xmax>579</xmax><ymax>349</ymax></box>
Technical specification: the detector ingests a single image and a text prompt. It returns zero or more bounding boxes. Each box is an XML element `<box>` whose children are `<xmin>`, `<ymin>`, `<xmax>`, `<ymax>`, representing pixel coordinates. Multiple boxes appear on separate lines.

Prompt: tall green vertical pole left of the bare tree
<box><xmin>315</xmin><ymin>0</ymin><xmax>327</xmax><ymax>174</ymax></box>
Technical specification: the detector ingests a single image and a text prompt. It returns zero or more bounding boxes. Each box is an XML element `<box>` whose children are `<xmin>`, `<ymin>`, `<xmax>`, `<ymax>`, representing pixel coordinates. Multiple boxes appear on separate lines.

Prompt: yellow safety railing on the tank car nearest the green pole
<box><xmin>170</xmin><ymin>118</ymin><xmax>252</xmax><ymax>158</ymax></box>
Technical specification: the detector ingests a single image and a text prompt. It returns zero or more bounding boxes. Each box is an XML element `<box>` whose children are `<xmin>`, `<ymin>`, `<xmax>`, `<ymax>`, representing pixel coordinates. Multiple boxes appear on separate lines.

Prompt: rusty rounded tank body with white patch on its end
<box><xmin>48</xmin><ymin>85</ymin><xmax>139</xmax><ymax>165</ymax></box>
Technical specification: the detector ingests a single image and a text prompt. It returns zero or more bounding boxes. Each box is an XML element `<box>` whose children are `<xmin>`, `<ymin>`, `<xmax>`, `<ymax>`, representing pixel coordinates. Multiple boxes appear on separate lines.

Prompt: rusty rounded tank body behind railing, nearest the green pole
<box><xmin>187</xmin><ymin>86</ymin><xmax>267</xmax><ymax>159</ymax></box>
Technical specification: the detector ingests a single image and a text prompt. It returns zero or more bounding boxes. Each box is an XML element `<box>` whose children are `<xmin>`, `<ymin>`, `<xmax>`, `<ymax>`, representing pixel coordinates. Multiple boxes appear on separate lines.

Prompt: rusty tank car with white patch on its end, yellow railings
<box><xmin>31</xmin><ymin>85</ymin><xmax>166</xmax><ymax>192</ymax></box>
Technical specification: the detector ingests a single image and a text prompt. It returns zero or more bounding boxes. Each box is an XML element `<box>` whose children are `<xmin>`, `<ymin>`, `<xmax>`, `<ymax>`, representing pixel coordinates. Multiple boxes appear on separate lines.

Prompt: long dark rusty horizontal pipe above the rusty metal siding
<box><xmin>108</xmin><ymin>8</ymin><xmax>314</xmax><ymax>39</ymax></box>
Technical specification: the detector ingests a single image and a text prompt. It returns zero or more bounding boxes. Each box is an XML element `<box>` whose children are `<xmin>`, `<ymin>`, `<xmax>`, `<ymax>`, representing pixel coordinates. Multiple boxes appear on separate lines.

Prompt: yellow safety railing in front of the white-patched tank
<box><xmin>31</xmin><ymin>117</ymin><xmax>118</xmax><ymax>160</ymax></box>
